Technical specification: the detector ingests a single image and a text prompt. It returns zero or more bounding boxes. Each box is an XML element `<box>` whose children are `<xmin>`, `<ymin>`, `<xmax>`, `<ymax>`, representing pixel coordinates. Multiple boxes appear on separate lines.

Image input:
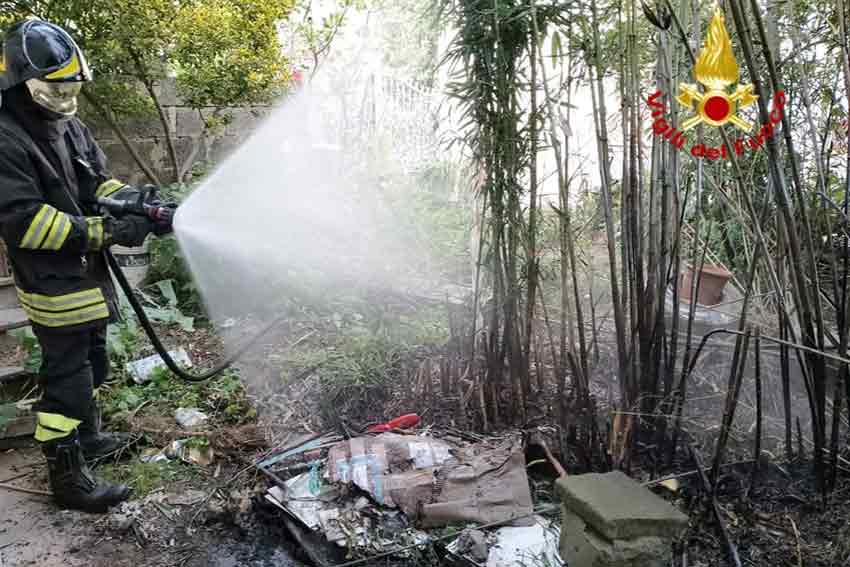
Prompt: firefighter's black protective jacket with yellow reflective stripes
<box><xmin>0</xmin><ymin>87</ymin><xmax>135</xmax><ymax>331</ymax></box>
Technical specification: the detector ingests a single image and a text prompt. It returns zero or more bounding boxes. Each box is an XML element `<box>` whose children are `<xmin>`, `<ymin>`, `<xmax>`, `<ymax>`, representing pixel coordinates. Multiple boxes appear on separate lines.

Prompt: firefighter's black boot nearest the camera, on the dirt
<box><xmin>41</xmin><ymin>431</ymin><xmax>130</xmax><ymax>513</ymax></box>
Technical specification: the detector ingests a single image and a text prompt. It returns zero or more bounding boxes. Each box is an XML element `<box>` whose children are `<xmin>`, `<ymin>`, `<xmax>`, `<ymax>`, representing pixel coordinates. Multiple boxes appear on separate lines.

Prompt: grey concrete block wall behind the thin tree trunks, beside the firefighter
<box><xmin>86</xmin><ymin>81</ymin><xmax>270</xmax><ymax>184</ymax></box>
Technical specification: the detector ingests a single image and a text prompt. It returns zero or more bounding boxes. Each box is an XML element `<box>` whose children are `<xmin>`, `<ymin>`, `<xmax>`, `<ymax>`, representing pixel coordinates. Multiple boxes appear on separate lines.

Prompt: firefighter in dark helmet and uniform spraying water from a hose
<box><xmin>0</xmin><ymin>19</ymin><xmax>170</xmax><ymax>512</ymax></box>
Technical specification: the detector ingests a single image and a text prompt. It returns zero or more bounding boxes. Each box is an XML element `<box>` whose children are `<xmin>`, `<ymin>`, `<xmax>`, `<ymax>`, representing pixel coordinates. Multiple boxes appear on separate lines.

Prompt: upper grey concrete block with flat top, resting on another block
<box><xmin>556</xmin><ymin>471</ymin><xmax>688</xmax><ymax>541</ymax></box>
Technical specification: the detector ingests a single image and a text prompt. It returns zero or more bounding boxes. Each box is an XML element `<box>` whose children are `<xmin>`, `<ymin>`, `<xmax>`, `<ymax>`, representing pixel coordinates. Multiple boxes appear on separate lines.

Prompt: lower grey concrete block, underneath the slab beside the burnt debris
<box><xmin>560</xmin><ymin>507</ymin><xmax>673</xmax><ymax>567</ymax></box>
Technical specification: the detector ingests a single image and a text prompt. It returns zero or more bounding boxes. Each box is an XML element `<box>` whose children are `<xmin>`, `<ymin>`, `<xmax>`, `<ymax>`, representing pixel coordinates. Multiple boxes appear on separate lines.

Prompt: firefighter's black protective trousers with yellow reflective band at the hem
<box><xmin>33</xmin><ymin>325</ymin><xmax>109</xmax><ymax>442</ymax></box>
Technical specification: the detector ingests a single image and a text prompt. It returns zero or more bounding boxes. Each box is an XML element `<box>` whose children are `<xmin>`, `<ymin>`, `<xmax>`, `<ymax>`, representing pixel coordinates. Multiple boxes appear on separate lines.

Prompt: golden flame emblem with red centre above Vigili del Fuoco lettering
<box><xmin>676</xmin><ymin>6</ymin><xmax>758</xmax><ymax>132</ymax></box>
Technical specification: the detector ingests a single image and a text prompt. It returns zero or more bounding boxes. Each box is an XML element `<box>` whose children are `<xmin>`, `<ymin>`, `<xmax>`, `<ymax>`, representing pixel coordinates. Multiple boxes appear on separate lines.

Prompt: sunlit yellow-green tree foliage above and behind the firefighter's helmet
<box><xmin>0</xmin><ymin>0</ymin><xmax>292</xmax><ymax>180</ymax></box>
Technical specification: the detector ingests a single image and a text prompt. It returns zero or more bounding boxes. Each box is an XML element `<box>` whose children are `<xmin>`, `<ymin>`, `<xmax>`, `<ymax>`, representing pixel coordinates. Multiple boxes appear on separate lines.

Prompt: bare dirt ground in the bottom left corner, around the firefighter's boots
<box><xmin>0</xmin><ymin>448</ymin><xmax>302</xmax><ymax>567</ymax></box>
